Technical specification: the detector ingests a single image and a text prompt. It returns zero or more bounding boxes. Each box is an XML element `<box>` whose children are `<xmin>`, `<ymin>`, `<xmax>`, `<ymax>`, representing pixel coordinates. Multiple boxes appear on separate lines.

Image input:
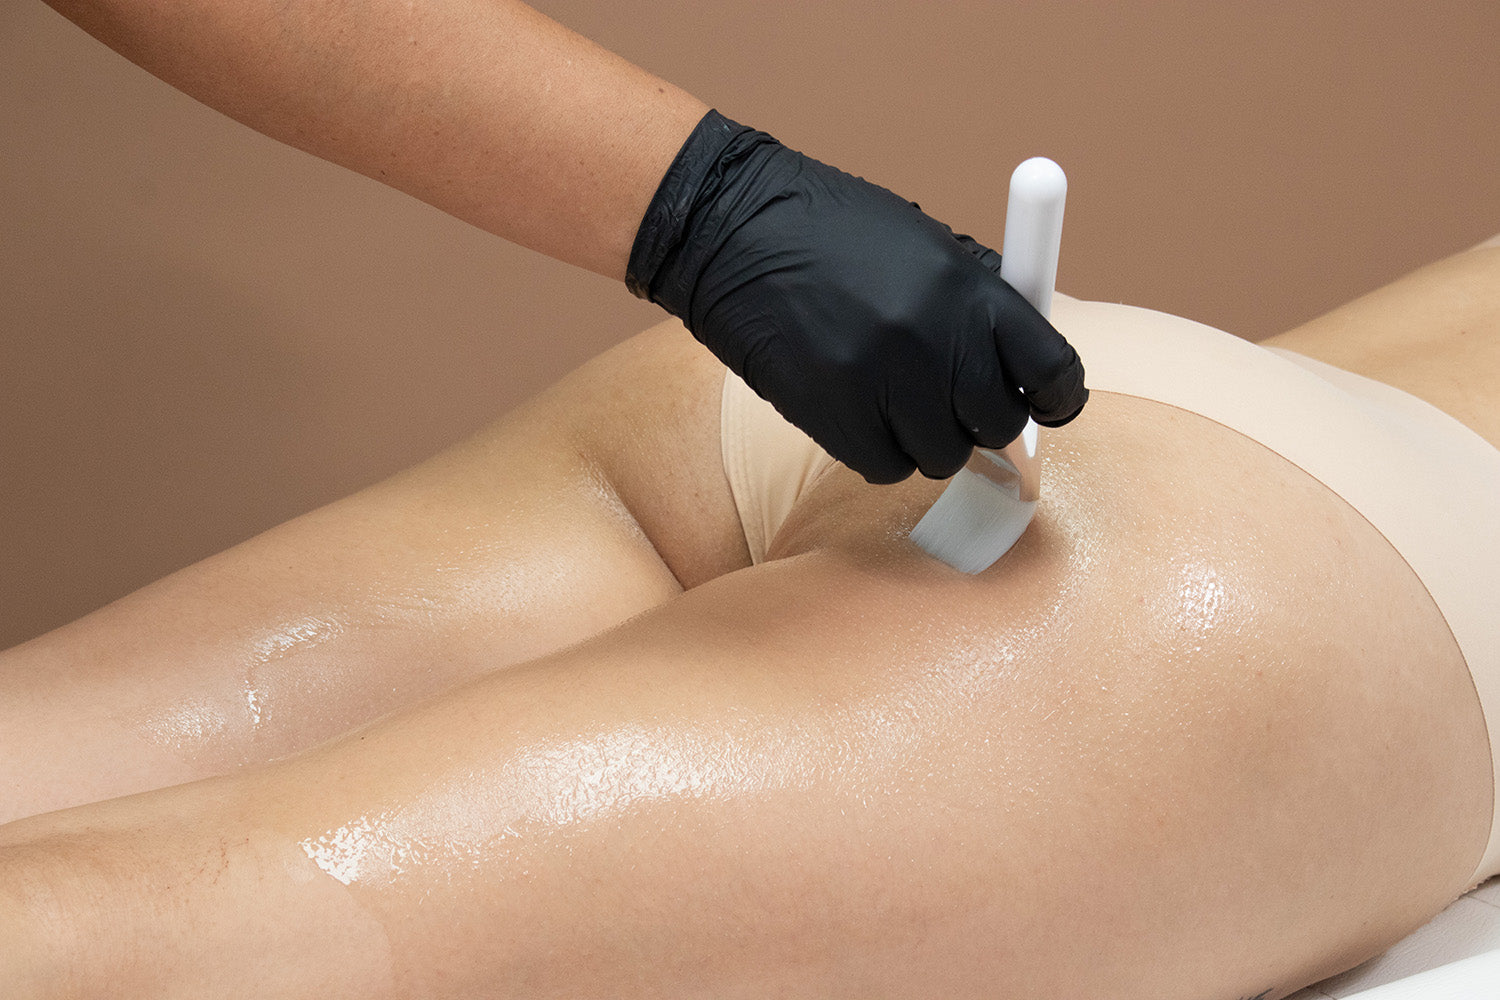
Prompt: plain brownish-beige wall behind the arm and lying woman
<box><xmin>0</xmin><ymin>0</ymin><xmax>1500</xmax><ymax>646</ymax></box>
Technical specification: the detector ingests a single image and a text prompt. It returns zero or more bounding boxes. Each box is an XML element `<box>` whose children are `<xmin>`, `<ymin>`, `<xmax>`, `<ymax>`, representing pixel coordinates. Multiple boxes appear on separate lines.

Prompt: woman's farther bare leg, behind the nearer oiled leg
<box><xmin>0</xmin><ymin>324</ymin><xmax>741</xmax><ymax>822</ymax></box>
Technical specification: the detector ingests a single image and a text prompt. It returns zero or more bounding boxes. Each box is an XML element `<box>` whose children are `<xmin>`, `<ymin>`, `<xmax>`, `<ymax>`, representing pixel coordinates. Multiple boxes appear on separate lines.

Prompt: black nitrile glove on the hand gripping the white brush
<box><xmin>626</xmin><ymin>111</ymin><xmax>1088</xmax><ymax>483</ymax></box>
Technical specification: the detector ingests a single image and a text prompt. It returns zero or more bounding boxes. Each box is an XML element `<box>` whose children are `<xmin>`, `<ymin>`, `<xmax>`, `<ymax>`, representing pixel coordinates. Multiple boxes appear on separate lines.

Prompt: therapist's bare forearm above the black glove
<box><xmin>48</xmin><ymin>0</ymin><xmax>707</xmax><ymax>279</ymax></box>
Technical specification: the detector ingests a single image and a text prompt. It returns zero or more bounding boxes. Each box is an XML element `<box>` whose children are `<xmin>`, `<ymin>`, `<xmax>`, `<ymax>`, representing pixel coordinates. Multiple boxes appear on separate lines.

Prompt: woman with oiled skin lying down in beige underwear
<box><xmin>0</xmin><ymin>238</ymin><xmax>1500</xmax><ymax>1000</ymax></box>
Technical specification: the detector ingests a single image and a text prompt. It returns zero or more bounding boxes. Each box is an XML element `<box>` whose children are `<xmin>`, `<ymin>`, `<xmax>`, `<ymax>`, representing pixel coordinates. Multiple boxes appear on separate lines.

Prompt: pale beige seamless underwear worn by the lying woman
<box><xmin>720</xmin><ymin>295</ymin><xmax>1500</xmax><ymax>882</ymax></box>
